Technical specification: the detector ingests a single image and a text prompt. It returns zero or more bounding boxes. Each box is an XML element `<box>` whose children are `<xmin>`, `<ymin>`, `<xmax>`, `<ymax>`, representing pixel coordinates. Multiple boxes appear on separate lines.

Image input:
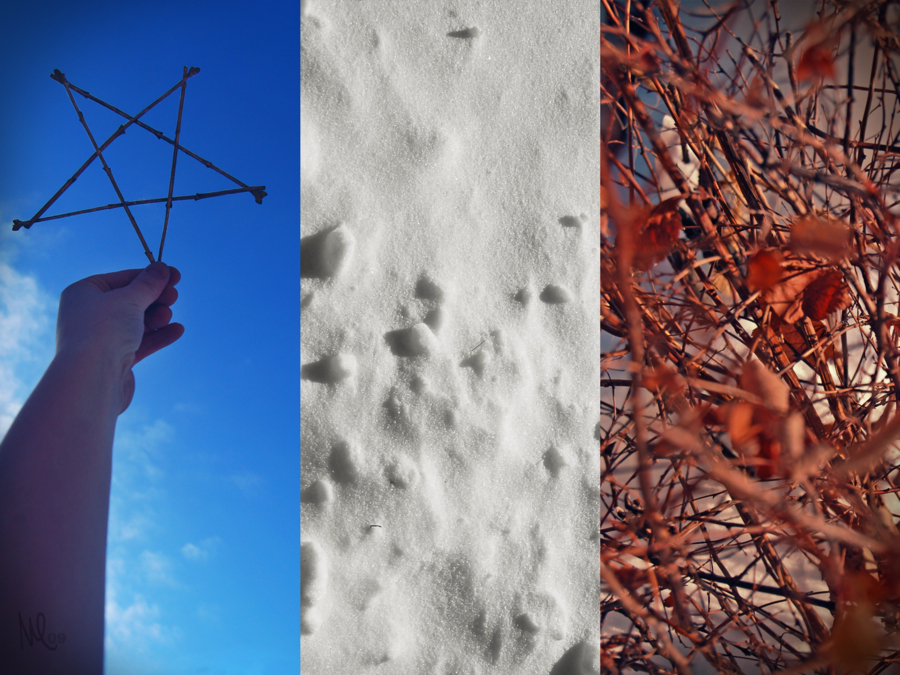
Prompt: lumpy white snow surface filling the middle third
<box><xmin>301</xmin><ymin>0</ymin><xmax>600</xmax><ymax>675</ymax></box>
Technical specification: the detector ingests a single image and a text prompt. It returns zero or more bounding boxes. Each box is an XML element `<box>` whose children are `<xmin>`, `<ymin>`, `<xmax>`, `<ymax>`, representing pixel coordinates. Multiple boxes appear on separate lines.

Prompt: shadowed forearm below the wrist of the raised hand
<box><xmin>0</xmin><ymin>350</ymin><xmax>124</xmax><ymax>675</ymax></box>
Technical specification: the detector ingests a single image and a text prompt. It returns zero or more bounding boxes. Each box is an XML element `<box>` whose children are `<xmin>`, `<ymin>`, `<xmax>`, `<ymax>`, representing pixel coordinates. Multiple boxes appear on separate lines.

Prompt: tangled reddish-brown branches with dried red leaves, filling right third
<box><xmin>597</xmin><ymin>0</ymin><xmax>900</xmax><ymax>674</ymax></box>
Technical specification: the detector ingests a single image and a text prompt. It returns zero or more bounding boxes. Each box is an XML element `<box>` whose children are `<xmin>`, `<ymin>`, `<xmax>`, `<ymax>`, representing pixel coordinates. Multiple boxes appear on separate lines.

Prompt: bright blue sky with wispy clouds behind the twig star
<box><xmin>0</xmin><ymin>0</ymin><xmax>300</xmax><ymax>675</ymax></box>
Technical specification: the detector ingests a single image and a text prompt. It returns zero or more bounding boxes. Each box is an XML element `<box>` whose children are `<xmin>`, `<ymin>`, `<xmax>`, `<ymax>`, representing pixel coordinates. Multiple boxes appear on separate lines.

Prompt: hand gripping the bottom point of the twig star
<box><xmin>56</xmin><ymin>262</ymin><xmax>184</xmax><ymax>411</ymax></box>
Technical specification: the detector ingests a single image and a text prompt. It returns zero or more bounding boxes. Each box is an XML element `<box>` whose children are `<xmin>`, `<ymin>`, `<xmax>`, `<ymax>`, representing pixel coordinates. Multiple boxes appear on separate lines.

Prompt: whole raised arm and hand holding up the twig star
<box><xmin>0</xmin><ymin>263</ymin><xmax>184</xmax><ymax>675</ymax></box>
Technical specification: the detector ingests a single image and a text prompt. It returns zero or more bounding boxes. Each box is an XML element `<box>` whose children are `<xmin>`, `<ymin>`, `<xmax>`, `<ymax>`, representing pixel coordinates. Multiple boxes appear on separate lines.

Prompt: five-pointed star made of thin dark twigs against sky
<box><xmin>13</xmin><ymin>66</ymin><xmax>266</xmax><ymax>262</ymax></box>
